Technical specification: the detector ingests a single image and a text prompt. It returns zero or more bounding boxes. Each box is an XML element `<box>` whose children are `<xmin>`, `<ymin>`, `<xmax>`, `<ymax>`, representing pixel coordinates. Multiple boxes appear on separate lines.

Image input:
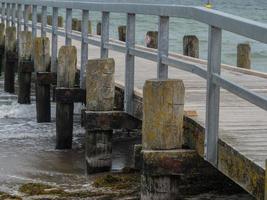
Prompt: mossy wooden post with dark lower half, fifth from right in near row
<box><xmin>18</xmin><ymin>31</ymin><xmax>33</xmax><ymax>104</ymax></box>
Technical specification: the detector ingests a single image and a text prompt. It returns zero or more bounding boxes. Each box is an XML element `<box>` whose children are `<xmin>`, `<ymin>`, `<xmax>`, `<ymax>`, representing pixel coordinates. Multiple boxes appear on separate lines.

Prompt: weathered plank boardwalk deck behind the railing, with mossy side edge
<box><xmin>48</xmin><ymin>31</ymin><xmax>267</xmax><ymax>199</ymax></box>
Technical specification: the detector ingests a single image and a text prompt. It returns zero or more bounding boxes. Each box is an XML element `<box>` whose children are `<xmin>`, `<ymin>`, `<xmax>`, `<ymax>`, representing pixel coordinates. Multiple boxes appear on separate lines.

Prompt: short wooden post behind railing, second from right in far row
<box><xmin>183</xmin><ymin>35</ymin><xmax>199</xmax><ymax>58</ymax></box>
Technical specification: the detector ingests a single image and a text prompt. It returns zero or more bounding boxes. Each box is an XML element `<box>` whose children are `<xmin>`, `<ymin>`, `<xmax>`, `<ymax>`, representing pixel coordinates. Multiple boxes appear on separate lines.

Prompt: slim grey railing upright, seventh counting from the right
<box><xmin>51</xmin><ymin>8</ymin><xmax>58</xmax><ymax>72</ymax></box>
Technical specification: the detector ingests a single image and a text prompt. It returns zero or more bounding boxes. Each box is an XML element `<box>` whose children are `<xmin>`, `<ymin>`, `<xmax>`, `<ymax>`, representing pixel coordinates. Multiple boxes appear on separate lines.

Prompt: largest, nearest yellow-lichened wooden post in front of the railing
<box><xmin>141</xmin><ymin>79</ymin><xmax>185</xmax><ymax>200</ymax></box>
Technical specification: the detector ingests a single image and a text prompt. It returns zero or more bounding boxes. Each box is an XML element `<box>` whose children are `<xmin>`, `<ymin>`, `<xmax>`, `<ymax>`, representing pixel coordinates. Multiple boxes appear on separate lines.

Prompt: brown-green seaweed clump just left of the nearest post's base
<box><xmin>93</xmin><ymin>174</ymin><xmax>140</xmax><ymax>190</ymax></box>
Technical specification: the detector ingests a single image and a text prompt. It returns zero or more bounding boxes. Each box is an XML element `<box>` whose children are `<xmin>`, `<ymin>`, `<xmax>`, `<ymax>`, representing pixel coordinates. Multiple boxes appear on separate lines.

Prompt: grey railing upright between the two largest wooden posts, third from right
<box><xmin>124</xmin><ymin>13</ymin><xmax>135</xmax><ymax>114</ymax></box>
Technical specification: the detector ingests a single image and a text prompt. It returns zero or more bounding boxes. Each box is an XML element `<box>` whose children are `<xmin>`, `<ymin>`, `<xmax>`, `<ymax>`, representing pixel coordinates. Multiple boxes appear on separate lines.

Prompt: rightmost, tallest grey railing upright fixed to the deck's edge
<box><xmin>205</xmin><ymin>26</ymin><xmax>222</xmax><ymax>166</ymax></box>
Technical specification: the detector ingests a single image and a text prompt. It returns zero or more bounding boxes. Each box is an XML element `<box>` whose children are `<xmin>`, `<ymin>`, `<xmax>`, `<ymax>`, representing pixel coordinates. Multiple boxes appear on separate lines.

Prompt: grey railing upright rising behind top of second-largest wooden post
<box><xmin>100</xmin><ymin>12</ymin><xmax>109</xmax><ymax>58</ymax></box>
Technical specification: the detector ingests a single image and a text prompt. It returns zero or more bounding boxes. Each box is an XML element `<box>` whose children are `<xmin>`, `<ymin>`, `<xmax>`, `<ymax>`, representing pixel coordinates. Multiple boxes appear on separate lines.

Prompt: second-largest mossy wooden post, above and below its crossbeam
<box><xmin>86</xmin><ymin>58</ymin><xmax>115</xmax><ymax>174</ymax></box>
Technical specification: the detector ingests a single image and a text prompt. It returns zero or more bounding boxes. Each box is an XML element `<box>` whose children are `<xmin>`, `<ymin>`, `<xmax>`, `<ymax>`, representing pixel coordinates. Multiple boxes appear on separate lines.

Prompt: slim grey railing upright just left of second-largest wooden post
<box><xmin>80</xmin><ymin>10</ymin><xmax>89</xmax><ymax>88</ymax></box>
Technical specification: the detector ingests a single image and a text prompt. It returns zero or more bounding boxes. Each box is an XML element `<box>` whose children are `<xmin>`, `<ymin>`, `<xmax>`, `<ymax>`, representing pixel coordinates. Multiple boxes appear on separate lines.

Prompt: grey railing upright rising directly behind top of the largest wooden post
<box><xmin>157</xmin><ymin>16</ymin><xmax>169</xmax><ymax>79</ymax></box>
